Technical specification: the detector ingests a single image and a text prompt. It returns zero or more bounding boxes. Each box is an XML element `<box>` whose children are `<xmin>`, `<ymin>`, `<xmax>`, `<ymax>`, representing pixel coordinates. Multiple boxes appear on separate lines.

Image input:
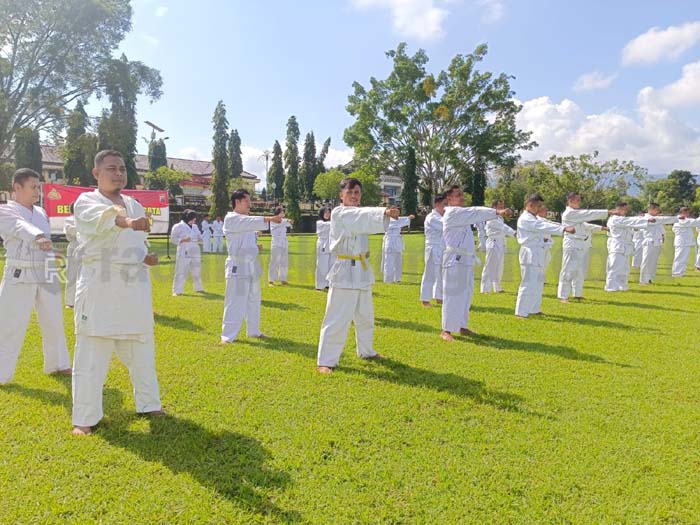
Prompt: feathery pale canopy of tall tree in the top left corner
<box><xmin>0</xmin><ymin>0</ymin><xmax>145</xmax><ymax>156</ymax></box>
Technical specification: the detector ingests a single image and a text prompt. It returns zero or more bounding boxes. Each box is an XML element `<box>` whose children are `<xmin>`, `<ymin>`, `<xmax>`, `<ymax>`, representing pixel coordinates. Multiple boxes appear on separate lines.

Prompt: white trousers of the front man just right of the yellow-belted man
<box><xmin>442</xmin><ymin>264</ymin><xmax>474</xmax><ymax>332</ymax></box>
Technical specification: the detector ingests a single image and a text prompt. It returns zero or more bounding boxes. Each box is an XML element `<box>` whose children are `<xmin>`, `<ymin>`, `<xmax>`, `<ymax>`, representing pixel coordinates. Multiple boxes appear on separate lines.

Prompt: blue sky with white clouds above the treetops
<box><xmin>98</xmin><ymin>0</ymin><xmax>700</xmax><ymax>178</ymax></box>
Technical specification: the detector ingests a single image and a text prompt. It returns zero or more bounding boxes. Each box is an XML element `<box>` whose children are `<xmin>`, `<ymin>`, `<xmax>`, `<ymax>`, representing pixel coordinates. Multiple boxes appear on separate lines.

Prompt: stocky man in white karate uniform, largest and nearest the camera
<box><xmin>72</xmin><ymin>150</ymin><xmax>164</xmax><ymax>435</ymax></box>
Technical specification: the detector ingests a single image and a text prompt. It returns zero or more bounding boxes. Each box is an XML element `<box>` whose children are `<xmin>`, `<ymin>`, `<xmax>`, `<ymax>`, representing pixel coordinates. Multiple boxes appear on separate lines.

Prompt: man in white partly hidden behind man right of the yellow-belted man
<box><xmin>420</xmin><ymin>193</ymin><xmax>447</xmax><ymax>306</ymax></box>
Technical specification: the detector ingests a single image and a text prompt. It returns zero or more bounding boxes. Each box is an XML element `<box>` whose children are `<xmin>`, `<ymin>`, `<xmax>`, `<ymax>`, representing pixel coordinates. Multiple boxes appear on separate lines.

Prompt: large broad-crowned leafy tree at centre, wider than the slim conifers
<box><xmin>344</xmin><ymin>43</ymin><xmax>536</xmax><ymax>200</ymax></box>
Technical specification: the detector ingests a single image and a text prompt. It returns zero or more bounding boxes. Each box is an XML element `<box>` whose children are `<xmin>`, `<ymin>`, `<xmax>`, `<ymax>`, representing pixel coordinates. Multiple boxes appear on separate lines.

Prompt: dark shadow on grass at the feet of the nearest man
<box><xmin>5</xmin><ymin>378</ymin><xmax>301</xmax><ymax>523</ymax></box>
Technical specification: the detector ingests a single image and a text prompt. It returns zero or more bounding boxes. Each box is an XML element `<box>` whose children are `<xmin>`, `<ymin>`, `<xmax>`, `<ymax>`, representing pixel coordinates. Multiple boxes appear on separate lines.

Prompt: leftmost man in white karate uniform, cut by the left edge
<box><xmin>0</xmin><ymin>168</ymin><xmax>71</xmax><ymax>385</ymax></box>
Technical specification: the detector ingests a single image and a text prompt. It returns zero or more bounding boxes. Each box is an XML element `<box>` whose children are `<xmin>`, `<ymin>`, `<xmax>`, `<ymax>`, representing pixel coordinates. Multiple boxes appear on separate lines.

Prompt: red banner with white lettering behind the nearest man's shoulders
<box><xmin>42</xmin><ymin>184</ymin><xmax>170</xmax><ymax>234</ymax></box>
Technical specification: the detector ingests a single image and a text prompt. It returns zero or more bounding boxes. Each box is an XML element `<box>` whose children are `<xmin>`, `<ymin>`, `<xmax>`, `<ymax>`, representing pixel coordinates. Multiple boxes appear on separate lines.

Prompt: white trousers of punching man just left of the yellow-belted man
<box><xmin>221</xmin><ymin>276</ymin><xmax>261</xmax><ymax>343</ymax></box>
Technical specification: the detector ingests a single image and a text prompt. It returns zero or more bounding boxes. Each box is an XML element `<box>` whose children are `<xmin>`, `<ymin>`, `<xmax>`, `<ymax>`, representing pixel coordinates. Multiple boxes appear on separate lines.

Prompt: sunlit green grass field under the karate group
<box><xmin>0</xmin><ymin>235</ymin><xmax>700</xmax><ymax>524</ymax></box>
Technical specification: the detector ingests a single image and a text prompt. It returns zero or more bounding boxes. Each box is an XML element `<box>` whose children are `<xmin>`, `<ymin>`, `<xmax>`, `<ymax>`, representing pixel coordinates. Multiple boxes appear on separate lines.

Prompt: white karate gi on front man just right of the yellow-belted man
<box><xmin>442</xmin><ymin>206</ymin><xmax>498</xmax><ymax>332</ymax></box>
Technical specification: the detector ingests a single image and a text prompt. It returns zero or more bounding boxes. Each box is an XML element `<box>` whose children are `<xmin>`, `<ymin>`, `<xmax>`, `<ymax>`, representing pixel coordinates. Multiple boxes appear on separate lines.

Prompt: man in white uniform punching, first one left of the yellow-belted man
<box><xmin>221</xmin><ymin>189</ymin><xmax>283</xmax><ymax>343</ymax></box>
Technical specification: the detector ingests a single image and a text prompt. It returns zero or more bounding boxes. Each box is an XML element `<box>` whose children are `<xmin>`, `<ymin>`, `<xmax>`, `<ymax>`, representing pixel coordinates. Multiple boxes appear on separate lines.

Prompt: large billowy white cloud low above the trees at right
<box><xmin>518</xmin><ymin>88</ymin><xmax>700</xmax><ymax>173</ymax></box>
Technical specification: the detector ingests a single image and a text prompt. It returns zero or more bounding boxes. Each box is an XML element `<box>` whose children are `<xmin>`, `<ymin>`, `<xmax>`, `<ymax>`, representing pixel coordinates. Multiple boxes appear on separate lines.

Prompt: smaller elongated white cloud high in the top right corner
<box><xmin>622</xmin><ymin>21</ymin><xmax>700</xmax><ymax>66</ymax></box>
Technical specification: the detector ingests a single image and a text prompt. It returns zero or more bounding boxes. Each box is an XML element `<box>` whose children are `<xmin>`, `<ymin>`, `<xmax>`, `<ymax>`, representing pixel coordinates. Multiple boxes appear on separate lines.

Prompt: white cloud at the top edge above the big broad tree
<box><xmin>350</xmin><ymin>0</ymin><xmax>448</xmax><ymax>40</ymax></box>
